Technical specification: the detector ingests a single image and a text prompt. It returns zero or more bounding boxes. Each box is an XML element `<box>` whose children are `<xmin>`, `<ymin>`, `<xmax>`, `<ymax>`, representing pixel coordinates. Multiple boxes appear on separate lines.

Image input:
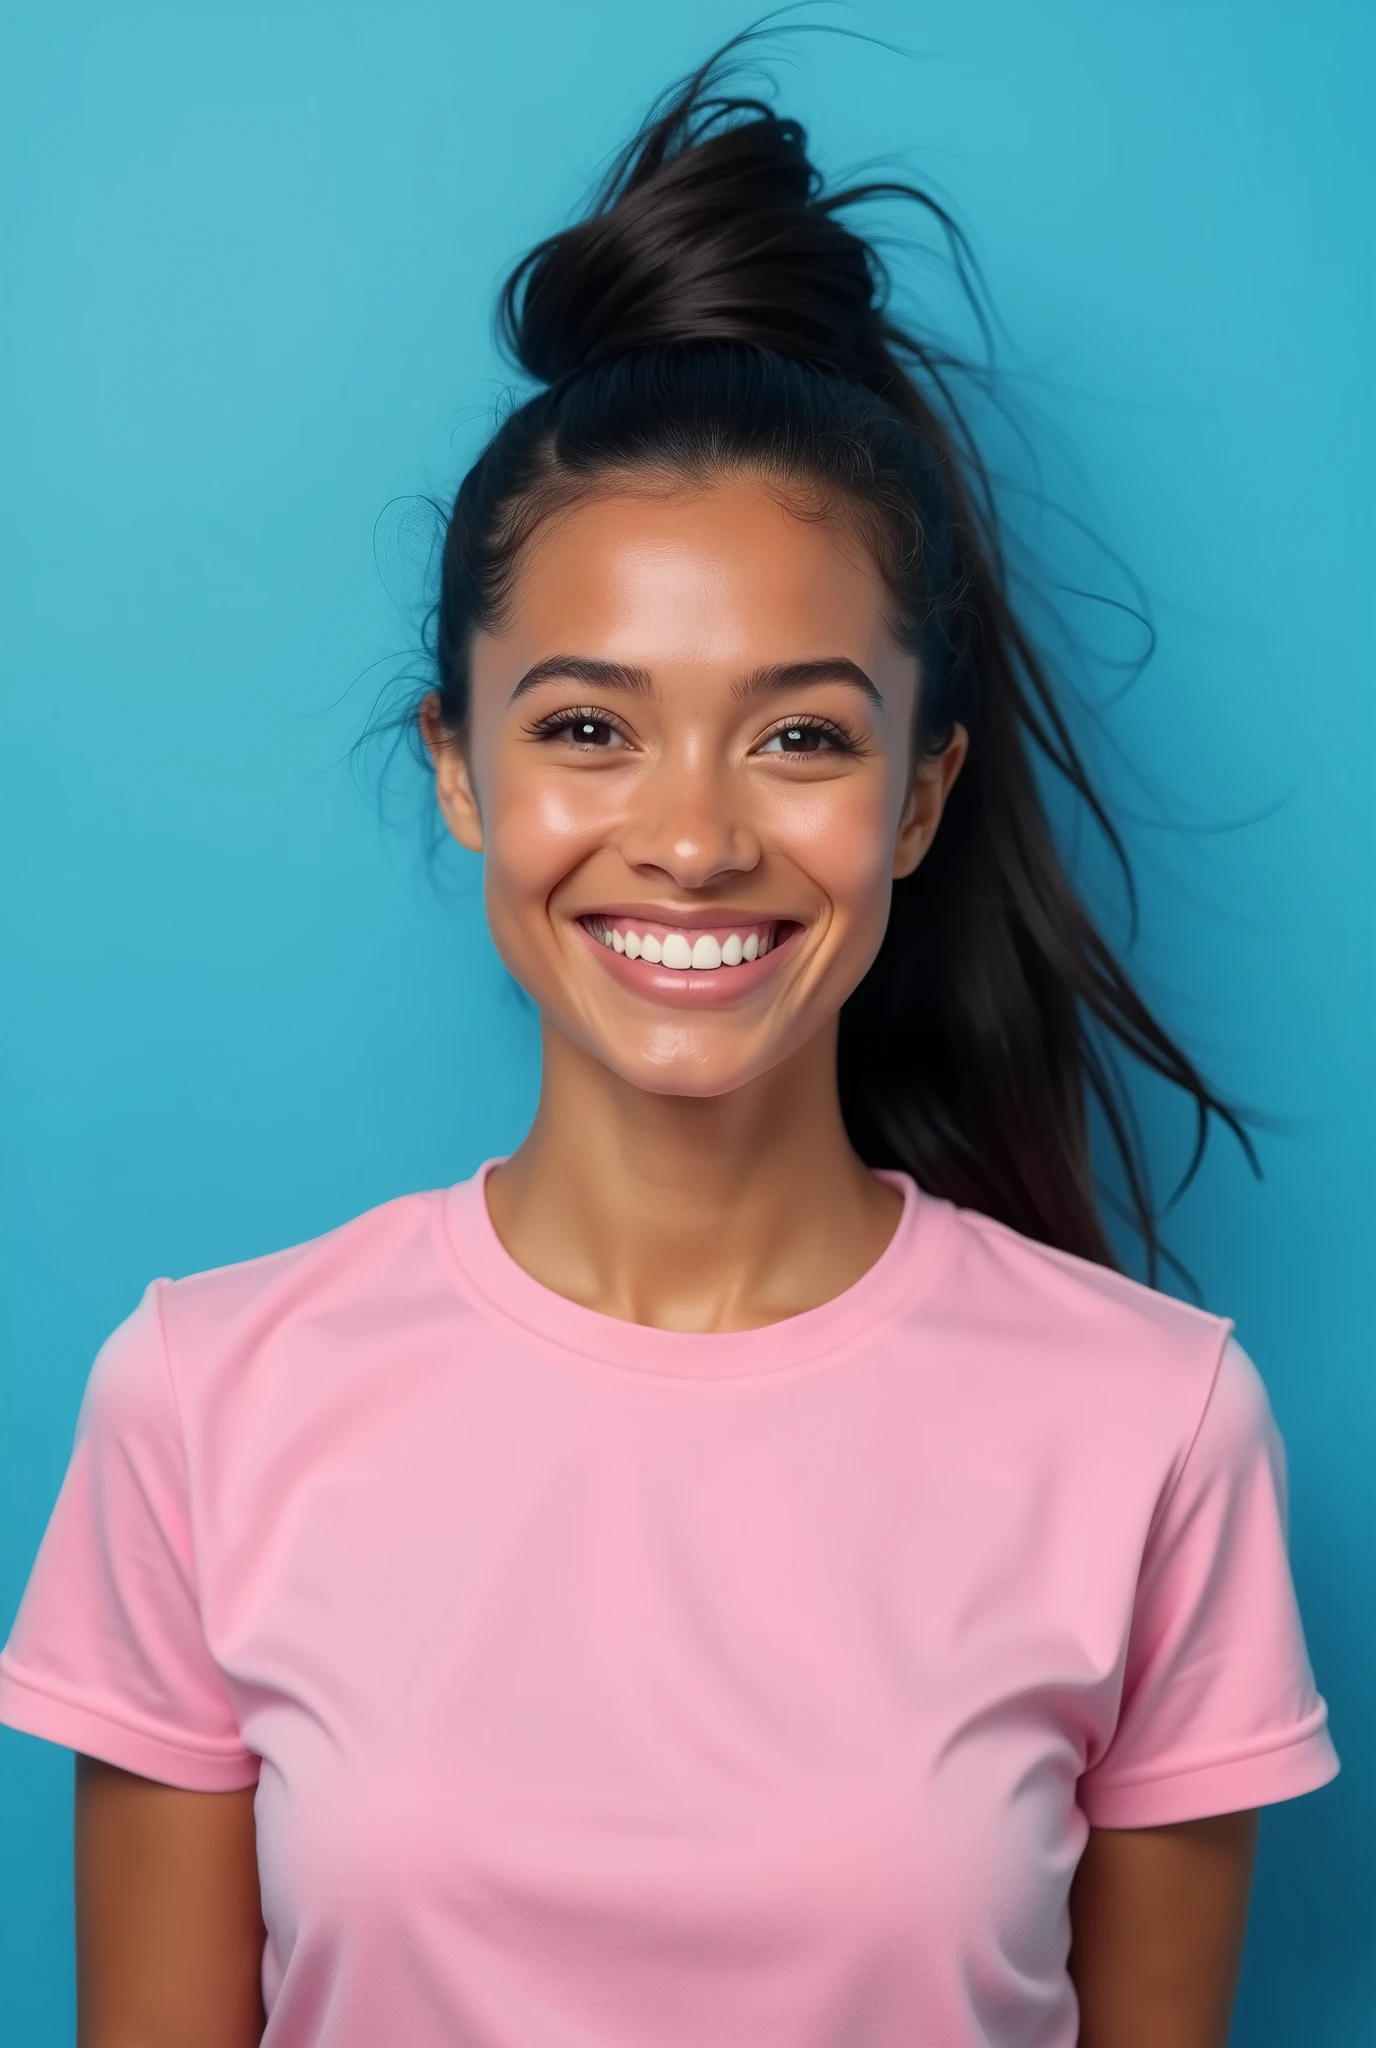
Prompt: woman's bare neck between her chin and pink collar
<box><xmin>487</xmin><ymin>1026</ymin><xmax>899</xmax><ymax>1331</ymax></box>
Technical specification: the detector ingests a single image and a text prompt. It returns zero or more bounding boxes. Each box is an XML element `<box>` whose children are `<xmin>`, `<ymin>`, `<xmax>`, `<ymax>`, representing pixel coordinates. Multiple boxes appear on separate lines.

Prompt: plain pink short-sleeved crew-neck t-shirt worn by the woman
<box><xmin>0</xmin><ymin>1174</ymin><xmax>1337</xmax><ymax>2048</ymax></box>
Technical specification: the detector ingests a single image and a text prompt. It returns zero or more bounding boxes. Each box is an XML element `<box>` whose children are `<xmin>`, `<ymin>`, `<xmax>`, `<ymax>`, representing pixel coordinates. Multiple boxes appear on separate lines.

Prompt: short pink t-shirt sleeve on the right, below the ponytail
<box><xmin>1079</xmin><ymin>1337</ymin><xmax>1337</xmax><ymax>1827</ymax></box>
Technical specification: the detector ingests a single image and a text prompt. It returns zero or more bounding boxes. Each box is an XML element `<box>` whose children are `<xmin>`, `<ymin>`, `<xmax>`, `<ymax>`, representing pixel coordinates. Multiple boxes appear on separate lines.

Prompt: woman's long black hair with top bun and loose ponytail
<box><xmin>421</xmin><ymin>31</ymin><xmax>1255</xmax><ymax>1278</ymax></box>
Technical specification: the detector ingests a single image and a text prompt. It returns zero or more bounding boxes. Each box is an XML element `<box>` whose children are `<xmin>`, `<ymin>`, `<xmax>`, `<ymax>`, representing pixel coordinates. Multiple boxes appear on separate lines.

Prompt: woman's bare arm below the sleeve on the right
<box><xmin>1071</xmin><ymin>1812</ymin><xmax>1257</xmax><ymax>2048</ymax></box>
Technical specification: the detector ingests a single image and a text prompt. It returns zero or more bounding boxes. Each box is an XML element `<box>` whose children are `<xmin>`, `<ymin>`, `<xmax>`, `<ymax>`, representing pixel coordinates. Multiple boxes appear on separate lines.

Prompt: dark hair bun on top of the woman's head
<box><xmin>498</xmin><ymin>54</ymin><xmax>891</xmax><ymax>385</ymax></box>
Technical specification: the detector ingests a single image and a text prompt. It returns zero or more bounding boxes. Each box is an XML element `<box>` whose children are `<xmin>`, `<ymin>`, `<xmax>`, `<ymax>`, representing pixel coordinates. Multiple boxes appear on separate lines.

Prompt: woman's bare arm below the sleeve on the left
<box><xmin>76</xmin><ymin>1757</ymin><xmax>264</xmax><ymax>2048</ymax></box>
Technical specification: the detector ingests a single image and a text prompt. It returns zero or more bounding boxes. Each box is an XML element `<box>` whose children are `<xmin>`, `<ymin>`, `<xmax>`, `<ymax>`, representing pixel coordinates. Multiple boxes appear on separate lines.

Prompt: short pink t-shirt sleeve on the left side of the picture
<box><xmin>0</xmin><ymin>1280</ymin><xmax>258</xmax><ymax>1792</ymax></box>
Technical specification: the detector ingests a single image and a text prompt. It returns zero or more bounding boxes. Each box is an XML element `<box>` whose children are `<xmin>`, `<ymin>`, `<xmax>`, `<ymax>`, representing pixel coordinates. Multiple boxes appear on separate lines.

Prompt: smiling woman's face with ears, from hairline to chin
<box><xmin>422</xmin><ymin>481</ymin><xmax>964</xmax><ymax>1096</ymax></box>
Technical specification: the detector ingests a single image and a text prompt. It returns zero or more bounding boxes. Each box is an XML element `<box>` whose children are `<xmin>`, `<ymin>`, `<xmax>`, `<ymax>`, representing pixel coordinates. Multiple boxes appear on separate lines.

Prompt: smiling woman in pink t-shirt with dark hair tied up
<box><xmin>0</xmin><ymin>36</ymin><xmax>1337</xmax><ymax>2048</ymax></box>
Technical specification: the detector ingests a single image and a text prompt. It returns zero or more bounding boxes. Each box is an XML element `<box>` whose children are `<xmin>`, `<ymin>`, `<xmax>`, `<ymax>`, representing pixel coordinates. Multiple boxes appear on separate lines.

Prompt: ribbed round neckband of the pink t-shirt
<box><xmin>438</xmin><ymin>1155</ymin><xmax>954</xmax><ymax>1382</ymax></box>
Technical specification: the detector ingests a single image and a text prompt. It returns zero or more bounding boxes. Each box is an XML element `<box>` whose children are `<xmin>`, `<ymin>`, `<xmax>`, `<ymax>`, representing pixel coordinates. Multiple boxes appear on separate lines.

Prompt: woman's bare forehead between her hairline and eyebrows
<box><xmin>496</xmin><ymin>479</ymin><xmax>907</xmax><ymax>674</ymax></box>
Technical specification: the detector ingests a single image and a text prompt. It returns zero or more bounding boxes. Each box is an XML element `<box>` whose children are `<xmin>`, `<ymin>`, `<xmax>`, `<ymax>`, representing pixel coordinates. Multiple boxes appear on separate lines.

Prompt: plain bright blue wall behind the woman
<box><xmin>0</xmin><ymin>0</ymin><xmax>1376</xmax><ymax>2048</ymax></box>
